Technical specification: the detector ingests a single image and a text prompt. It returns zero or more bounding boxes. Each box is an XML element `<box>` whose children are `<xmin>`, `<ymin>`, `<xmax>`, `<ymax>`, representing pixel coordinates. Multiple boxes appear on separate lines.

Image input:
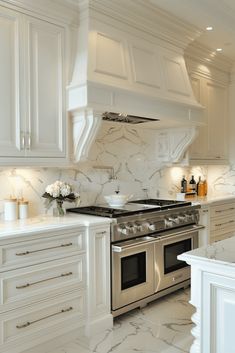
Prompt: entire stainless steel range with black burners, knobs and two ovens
<box><xmin>69</xmin><ymin>199</ymin><xmax>203</xmax><ymax>316</ymax></box>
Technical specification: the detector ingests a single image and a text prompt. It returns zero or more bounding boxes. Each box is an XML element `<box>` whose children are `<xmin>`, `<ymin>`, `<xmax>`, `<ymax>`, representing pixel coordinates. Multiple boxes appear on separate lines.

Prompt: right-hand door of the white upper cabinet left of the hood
<box><xmin>25</xmin><ymin>17</ymin><xmax>66</xmax><ymax>157</ymax></box>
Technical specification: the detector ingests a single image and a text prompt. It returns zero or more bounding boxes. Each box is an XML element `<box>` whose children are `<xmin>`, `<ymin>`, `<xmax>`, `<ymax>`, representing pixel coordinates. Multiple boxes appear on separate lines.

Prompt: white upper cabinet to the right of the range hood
<box><xmin>189</xmin><ymin>74</ymin><xmax>228</xmax><ymax>164</ymax></box>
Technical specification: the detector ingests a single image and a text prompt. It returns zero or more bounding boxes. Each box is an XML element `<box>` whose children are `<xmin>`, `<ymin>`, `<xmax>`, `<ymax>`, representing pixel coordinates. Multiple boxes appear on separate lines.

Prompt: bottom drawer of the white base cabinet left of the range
<box><xmin>0</xmin><ymin>291</ymin><xmax>85</xmax><ymax>346</ymax></box>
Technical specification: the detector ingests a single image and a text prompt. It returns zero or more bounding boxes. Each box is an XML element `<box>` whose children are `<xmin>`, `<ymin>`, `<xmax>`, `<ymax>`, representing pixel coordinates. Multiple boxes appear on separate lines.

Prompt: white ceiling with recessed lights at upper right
<box><xmin>150</xmin><ymin>0</ymin><xmax>235</xmax><ymax>60</ymax></box>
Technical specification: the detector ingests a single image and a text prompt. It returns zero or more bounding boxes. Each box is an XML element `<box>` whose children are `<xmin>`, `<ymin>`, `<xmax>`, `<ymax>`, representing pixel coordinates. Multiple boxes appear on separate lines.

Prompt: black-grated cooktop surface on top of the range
<box><xmin>67</xmin><ymin>199</ymin><xmax>191</xmax><ymax>218</ymax></box>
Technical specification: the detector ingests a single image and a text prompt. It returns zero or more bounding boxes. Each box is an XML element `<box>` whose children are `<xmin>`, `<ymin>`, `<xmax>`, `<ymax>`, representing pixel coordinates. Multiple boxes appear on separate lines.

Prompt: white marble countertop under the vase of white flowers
<box><xmin>0</xmin><ymin>214</ymin><xmax>111</xmax><ymax>239</ymax></box>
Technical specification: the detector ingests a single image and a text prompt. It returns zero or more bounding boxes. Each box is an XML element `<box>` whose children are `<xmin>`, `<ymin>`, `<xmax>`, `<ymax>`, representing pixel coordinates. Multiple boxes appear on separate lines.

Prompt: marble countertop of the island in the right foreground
<box><xmin>178</xmin><ymin>235</ymin><xmax>235</xmax><ymax>268</ymax></box>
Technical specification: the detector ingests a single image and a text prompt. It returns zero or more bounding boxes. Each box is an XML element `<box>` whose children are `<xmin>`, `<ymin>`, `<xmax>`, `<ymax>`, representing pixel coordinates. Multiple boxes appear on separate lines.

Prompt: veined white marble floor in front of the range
<box><xmin>50</xmin><ymin>289</ymin><xmax>194</xmax><ymax>353</ymax></box>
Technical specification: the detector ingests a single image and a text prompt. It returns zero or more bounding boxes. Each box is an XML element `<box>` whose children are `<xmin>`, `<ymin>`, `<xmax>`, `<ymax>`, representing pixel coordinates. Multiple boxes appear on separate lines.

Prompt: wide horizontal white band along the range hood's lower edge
<box><xmin>68</xmin><ymin>82</ymin><xmax>204</xmax><ymax>129</ymax></box>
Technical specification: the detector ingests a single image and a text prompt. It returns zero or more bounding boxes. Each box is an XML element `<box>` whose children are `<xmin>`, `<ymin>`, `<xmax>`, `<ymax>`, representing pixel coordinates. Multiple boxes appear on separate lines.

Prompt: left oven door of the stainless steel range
<box><xmin>112</xmin><ymin>236</ymin><xmax>155</xmax><ymax>310</ymax></box>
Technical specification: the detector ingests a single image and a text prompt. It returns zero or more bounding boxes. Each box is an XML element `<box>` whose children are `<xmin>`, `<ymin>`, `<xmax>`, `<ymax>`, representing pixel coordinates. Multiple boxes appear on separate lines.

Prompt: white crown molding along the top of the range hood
<box><xmin>78</xmin><ymin>0</ymin><xmax>202</xmax><ymax>49</ymax></box>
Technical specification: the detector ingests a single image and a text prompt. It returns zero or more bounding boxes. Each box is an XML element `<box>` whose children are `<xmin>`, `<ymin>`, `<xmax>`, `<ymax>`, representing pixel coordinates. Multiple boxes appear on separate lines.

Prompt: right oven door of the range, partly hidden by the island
<box><xmin>154</xmin><ymin>225</ymin><xmax>203</xmax><ymax>292</ymax></box>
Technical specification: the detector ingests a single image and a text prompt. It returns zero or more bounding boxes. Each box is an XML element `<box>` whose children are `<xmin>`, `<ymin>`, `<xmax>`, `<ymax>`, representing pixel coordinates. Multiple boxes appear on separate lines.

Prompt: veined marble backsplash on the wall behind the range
<box><xmin>0</xmin><ymin>125</ymin><xmax>235</xmax><ymax>217</ymax></box>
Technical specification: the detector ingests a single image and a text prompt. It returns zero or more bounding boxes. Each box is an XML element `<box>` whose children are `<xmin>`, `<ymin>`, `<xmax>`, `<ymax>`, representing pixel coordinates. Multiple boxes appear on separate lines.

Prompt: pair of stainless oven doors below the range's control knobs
<box><xmin>112</xmin><ymin>226</ymin><xmax>201</xmax><ymax>315</ymax></box>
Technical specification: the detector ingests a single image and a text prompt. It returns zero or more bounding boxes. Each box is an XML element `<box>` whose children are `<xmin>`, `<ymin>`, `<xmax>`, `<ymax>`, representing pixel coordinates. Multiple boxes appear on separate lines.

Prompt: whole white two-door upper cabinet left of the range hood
<box><xmin>0</xmin><ymin>6</ymin><xmax>66</xmax><ymax>165</ymax></box>
